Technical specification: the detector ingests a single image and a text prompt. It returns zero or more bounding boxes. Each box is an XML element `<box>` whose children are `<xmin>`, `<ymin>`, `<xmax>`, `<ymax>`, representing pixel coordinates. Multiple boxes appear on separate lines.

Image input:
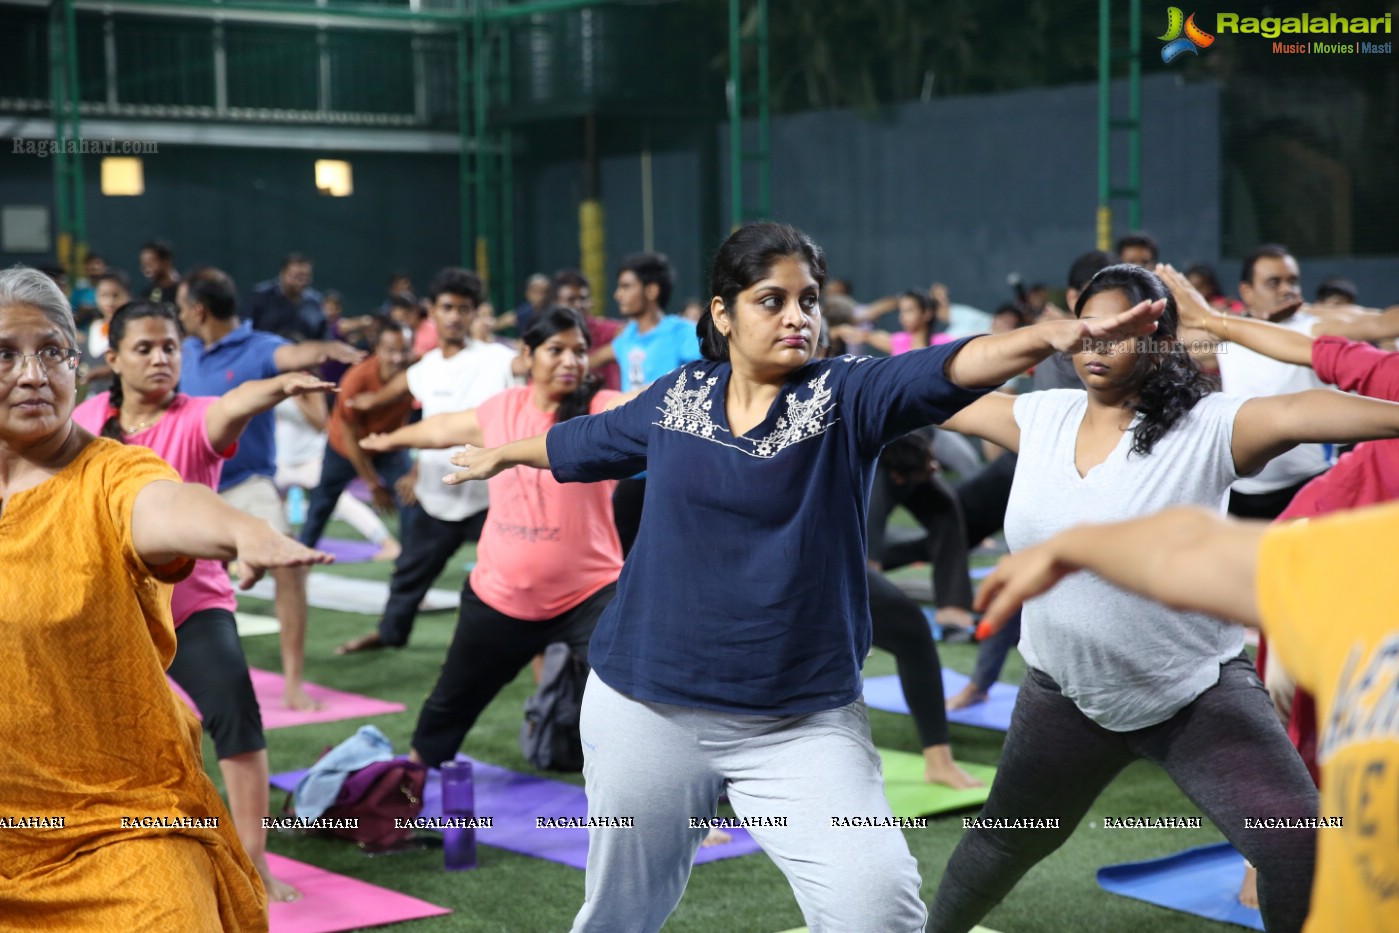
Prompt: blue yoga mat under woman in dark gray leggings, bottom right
<box><xmin>1098</xmin><ymin>842</ymin><xmax>1263</xmax><ymax>930</ymax></box>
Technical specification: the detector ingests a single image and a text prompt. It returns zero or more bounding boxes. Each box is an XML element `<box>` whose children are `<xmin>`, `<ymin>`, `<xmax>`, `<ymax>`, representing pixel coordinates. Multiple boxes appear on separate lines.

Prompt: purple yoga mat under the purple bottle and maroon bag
<box><xmin>271</xmin><ymin>754</ymin><xmax>760</xmax><ymax>869</ymax></box>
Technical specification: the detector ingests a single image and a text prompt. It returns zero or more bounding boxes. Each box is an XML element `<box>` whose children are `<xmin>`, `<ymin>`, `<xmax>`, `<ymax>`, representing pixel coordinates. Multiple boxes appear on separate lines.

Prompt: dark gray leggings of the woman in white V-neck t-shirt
<box><xmin>928</xmin><ymin>655</ymin><xmax>1330</xmax><ymax>933</ymax></box>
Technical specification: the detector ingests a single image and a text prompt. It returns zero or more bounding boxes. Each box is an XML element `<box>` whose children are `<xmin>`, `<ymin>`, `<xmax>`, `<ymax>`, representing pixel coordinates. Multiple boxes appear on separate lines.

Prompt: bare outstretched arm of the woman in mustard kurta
<box><xmin>132</xmin><ymin>480</ymin><xmax>334</xmax><ymax>589</ymax></box>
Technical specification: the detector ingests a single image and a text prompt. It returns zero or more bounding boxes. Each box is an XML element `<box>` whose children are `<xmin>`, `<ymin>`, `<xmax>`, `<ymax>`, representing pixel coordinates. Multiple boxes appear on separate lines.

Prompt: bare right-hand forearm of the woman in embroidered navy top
<box><xmin>946</xmin><ymin>301</ymin><xmax>1165</xmax><ymax>389</ymax></box>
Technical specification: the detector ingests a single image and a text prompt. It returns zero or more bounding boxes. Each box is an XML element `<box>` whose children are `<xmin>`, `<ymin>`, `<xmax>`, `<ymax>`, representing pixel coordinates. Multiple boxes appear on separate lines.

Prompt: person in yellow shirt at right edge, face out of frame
<box><xmin>977</xmin><ymin>504</ymin><xmax>1399</xmax><ymax>933</ymax></box>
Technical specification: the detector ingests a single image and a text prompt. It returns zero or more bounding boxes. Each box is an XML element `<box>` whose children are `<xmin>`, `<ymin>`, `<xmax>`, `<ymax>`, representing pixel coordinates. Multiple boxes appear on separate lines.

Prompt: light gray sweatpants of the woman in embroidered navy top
<box><xmin>574</xmin><ymin>674</ymin><xmax>928</xmax><ymax>933</ymax></box>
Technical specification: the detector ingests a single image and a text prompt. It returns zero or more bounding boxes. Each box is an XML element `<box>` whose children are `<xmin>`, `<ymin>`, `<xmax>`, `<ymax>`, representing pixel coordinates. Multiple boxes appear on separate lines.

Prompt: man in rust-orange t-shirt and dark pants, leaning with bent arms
<box><xmin>301</xmin><ymin>322</ymin><xmax>413</xmax><ymax>551</ymax></box>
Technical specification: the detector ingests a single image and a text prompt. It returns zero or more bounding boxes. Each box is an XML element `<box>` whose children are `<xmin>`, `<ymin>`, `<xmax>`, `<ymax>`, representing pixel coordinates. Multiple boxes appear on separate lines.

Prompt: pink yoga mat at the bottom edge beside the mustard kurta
<box><xmin>267</xmin><ymin>852</ymin><xmax>452</xmax><ymax>933</ymax></box>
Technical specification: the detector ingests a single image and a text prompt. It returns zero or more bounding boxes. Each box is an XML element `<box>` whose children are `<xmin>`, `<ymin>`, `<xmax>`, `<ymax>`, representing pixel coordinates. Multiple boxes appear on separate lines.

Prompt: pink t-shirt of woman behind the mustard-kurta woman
<box><xmin>73</xmin><ymin>392</ymin><xmax>238</xmax><ymax>628</ymax></box>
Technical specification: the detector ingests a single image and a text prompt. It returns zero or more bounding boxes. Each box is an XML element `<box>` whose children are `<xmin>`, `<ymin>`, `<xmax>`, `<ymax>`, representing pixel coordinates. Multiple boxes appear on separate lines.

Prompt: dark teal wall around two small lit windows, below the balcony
<box><xmin>0</xmin><ymin>144</ymin><xmax>460</xmax><ymax>311</ymax></box>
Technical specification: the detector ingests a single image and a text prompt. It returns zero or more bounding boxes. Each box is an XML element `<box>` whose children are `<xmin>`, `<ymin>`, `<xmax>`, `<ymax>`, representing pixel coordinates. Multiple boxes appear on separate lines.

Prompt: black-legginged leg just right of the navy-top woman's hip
<box><xmin>865</xmin><ymin>571</ymin><xmax>947</xmax><ymax>748</ymax></box>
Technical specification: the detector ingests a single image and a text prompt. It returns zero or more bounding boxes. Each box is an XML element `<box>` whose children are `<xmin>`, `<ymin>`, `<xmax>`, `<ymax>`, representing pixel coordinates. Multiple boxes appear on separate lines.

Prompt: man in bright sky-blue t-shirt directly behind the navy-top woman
<box><xmin>589</xmin><ymin>253</ymin><xmax>700</xmax><ymax>554</ymax></box>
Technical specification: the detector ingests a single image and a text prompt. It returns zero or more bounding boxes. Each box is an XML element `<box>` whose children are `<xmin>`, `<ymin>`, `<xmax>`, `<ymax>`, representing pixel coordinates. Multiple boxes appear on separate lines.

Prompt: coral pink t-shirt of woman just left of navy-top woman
<box><xmin>471</xmin><ymin>386</ymin><xmax>621</xmax><ymax>621</ymax></box>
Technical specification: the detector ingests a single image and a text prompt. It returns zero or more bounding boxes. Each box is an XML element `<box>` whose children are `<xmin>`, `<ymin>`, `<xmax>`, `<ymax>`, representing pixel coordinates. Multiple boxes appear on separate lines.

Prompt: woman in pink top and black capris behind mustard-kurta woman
<box><xmin>73</xmin><ymin>301</ymin><xmax>334</xmax><ymax>901</ymax></box>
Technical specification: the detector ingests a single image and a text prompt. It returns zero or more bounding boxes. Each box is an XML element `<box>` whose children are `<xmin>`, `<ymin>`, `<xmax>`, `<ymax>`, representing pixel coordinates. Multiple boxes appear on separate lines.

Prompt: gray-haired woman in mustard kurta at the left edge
<box><xmin>0</xmin><ymin>266</ymin><xmax>330</xmax><ymax>933</ymax></box>
